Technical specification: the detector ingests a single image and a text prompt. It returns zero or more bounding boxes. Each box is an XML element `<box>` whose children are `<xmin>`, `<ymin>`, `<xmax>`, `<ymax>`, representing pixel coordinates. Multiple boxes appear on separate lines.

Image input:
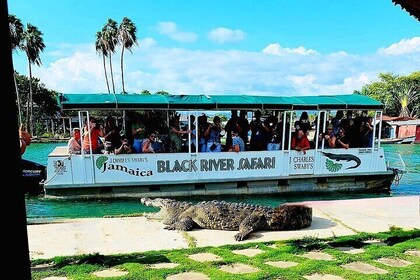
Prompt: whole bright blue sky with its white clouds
<box><xmin>8</xmin><ymin>0</ymin><xmax>420</xmax><ymax>96</ymax></box>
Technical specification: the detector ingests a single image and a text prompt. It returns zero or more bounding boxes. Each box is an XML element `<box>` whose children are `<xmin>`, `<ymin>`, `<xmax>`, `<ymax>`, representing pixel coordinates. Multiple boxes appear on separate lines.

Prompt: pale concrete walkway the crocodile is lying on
<box><xmin>28</xmin><ymin>196</ymin><xmax>420</xmax><ymax>259</ymax></box>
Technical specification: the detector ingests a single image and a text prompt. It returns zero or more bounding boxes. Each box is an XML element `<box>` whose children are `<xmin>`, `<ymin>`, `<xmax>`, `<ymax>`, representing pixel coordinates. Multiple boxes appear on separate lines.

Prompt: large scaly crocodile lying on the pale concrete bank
<box><xmin>140</xmin><ymin>198</ymin><xmax>312</xmax><ymax>241</ymax></box>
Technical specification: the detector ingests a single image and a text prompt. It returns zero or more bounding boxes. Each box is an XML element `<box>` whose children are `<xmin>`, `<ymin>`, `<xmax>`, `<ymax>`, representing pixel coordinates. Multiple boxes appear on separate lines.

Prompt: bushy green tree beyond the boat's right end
<box><xmin>355</xmin><ymin>71</ymin><xmax>420</xmax><ymax>117</ymax></box>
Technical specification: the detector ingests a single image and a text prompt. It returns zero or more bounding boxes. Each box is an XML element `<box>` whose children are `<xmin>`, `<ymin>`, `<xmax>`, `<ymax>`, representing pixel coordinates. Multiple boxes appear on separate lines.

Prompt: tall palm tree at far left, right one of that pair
<box><xmin>22</xmin><ymin>23</ymin><xmax>45</xmax><ymax>133</ymax></box>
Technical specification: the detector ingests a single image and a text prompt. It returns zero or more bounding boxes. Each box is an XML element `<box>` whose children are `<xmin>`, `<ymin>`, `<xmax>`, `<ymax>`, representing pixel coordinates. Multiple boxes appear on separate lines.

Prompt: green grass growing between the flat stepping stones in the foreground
<box><xmin>32</xmin><ymin>228</ymin><xmax>420</xmax><ymax>280</ymax></box>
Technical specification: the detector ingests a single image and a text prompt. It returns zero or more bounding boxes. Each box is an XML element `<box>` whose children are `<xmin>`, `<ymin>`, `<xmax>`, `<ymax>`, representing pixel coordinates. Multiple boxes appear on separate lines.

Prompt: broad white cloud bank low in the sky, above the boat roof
<box><xmin>24</xmin><ymin>38</ymin><xmax>420</xmax><ymax>95</ymax></box>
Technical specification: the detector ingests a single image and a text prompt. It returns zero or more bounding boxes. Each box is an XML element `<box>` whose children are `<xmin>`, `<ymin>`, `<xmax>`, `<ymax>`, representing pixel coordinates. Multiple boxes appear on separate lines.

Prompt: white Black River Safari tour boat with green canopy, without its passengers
<box><xmin>43</xmin><ymin>93</ymin><xmax>404</xmax><ymax>198</ymax></box>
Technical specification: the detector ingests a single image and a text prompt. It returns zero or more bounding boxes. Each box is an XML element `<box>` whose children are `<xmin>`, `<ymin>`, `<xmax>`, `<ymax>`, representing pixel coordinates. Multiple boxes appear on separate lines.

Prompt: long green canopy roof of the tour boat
<box><xmin>58</xmin><ymin>93</ymin><xmax>384</xmax><ymax>110</ymax></box>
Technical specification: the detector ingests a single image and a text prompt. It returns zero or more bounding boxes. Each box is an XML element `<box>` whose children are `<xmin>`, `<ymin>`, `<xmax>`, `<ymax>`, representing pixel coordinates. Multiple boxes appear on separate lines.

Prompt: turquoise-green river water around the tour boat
<box><xmin>23</xmin><ymin>143</ymin><xmax>420</xmax><ymax>222</ymax></box>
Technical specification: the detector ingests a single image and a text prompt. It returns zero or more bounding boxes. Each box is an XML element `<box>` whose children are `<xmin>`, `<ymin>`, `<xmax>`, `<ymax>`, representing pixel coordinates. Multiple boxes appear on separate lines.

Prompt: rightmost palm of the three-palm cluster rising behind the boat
<box><xmin>118</xmin><ymin>17</ymin><xmax>137</xmax><ymax>93</ymax></box>
